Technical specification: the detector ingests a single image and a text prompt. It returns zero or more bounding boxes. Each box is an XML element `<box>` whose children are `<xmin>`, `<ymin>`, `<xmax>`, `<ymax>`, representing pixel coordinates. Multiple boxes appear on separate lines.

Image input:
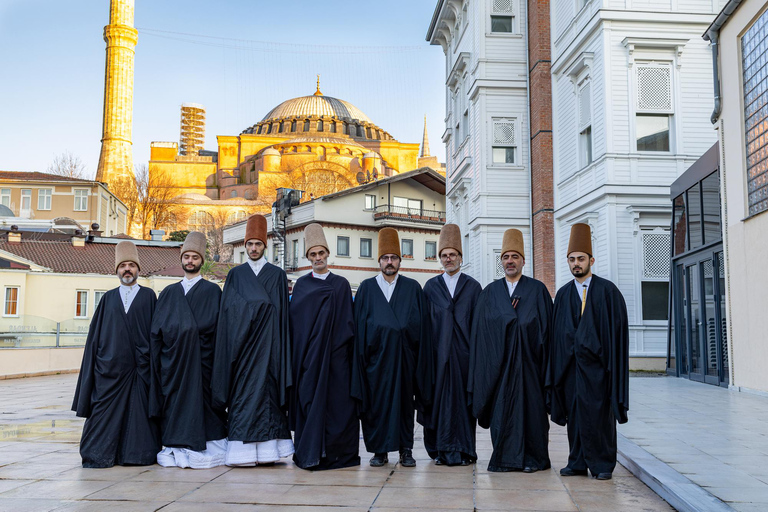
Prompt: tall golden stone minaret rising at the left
<box><xmin>96</xmin><ymin>0</ymin><xmax>139</xmax><ymax>184</ymax></box>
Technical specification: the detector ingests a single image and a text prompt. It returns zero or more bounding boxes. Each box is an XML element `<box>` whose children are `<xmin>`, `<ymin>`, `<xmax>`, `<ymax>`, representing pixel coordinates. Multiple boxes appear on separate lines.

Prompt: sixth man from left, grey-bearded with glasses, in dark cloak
<box><xmin>421</xmin><ymin>224</ymin><xmax>482</xmax><ymax>466</ymax></box>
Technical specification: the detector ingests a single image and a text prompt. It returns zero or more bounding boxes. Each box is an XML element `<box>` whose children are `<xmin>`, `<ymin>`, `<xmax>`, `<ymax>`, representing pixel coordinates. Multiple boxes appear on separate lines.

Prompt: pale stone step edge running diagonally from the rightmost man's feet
<box><xmin>617</xmin><ymin>432</ymin><xmax>735</xmax><ymax>512</ymax></box>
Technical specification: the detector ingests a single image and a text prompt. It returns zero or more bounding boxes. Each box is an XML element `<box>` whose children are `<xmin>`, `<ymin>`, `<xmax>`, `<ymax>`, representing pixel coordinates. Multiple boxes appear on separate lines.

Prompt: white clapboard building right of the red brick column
<box><xmin>551</xmin><ymin>0</ymin><xmax>724</xmax><ymax>369</ymax></box>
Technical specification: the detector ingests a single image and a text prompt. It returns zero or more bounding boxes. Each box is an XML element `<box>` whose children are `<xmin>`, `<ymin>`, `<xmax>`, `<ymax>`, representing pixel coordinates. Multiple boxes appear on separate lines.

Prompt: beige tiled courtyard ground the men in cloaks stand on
<box><xmin>0</xmin><ymin>375</ymin><xmax>672</xmax><ymax>512</ymax></box>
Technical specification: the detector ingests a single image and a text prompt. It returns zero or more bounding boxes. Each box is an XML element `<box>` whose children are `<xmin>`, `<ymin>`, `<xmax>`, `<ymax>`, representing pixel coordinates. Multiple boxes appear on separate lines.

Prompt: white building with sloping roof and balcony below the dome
<box><xmin>224</xmin><ymin>168</ymin><xmax>445</xmax><ymax>291</ymax></box>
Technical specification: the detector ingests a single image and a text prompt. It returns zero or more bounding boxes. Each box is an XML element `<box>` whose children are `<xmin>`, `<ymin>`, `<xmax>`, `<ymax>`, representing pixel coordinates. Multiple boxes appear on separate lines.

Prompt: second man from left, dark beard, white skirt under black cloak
<box><xmin>150</xmin><ymin>231</ymin><xmax>227</xmax><ymax>469</ymax></box>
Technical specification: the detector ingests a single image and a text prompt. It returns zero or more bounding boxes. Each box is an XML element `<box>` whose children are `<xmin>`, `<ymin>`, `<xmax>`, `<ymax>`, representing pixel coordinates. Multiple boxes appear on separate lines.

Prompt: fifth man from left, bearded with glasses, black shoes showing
<box><xmin>352</xmin><ymin>228</ymin><xmax>432</xmax><ymax>467</ymax></box>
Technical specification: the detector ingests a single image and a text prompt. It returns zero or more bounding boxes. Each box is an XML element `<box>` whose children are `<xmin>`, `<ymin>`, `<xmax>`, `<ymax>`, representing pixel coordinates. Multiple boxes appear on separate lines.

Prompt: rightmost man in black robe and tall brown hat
<box><xmin>550</xmin><ymin>224</ymin><xmax>629</xmax><ymax>480</ymax></box>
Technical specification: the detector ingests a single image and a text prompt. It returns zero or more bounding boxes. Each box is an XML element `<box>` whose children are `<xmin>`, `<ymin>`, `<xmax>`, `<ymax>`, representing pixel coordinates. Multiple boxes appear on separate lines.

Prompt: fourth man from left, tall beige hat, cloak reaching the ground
<box><xmin>289</xmin><ymin>224</ymin><xmax>360</xmax><ymax>470</ymax></box>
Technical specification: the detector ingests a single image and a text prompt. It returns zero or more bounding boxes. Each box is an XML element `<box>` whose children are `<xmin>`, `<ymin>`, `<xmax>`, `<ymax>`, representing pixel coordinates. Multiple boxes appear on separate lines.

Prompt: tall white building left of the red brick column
<box><xmin>427</xmin><ymin>0</ymin><xmax>536</xmax><ymax>285</ymax></box>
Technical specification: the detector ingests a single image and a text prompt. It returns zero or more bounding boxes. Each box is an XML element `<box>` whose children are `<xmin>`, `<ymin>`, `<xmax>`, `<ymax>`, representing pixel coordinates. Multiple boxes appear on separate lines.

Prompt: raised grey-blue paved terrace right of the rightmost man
<box><xmin>619</xmin><ymin>377</ymin><xmax>768</xmax><ymax>512</ymax></box>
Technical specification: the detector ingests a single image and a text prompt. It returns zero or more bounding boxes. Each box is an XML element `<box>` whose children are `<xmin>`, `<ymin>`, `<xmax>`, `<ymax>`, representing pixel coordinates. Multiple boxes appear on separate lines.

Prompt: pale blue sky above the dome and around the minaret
<box><xmin>0</xmin><ymin>0</ymin><xmax>445</xmax><ymax>178</ymax></box>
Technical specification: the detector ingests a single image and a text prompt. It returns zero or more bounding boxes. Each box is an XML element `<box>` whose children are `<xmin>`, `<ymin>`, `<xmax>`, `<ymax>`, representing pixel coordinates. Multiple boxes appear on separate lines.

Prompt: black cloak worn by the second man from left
<box><xmin>150</xmin><ymin>279</ymin><xmax>227</xmax><ymax>452</ymax></box>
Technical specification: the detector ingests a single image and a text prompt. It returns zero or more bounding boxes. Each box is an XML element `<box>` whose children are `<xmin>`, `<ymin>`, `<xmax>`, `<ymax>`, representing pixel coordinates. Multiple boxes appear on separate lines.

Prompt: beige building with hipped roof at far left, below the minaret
<box><xmin>0</xmin><ymin>171</ymin><xmax>128</xmax><ymax>236</ymax></box>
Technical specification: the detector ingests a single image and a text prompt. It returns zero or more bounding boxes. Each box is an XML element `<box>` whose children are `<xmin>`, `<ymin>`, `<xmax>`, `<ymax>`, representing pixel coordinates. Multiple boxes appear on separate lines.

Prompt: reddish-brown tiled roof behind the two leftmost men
<box><xmin>0</xmin><ymin>231</ymin><xmax>180</xmax><ymax>277</ymax></box>
